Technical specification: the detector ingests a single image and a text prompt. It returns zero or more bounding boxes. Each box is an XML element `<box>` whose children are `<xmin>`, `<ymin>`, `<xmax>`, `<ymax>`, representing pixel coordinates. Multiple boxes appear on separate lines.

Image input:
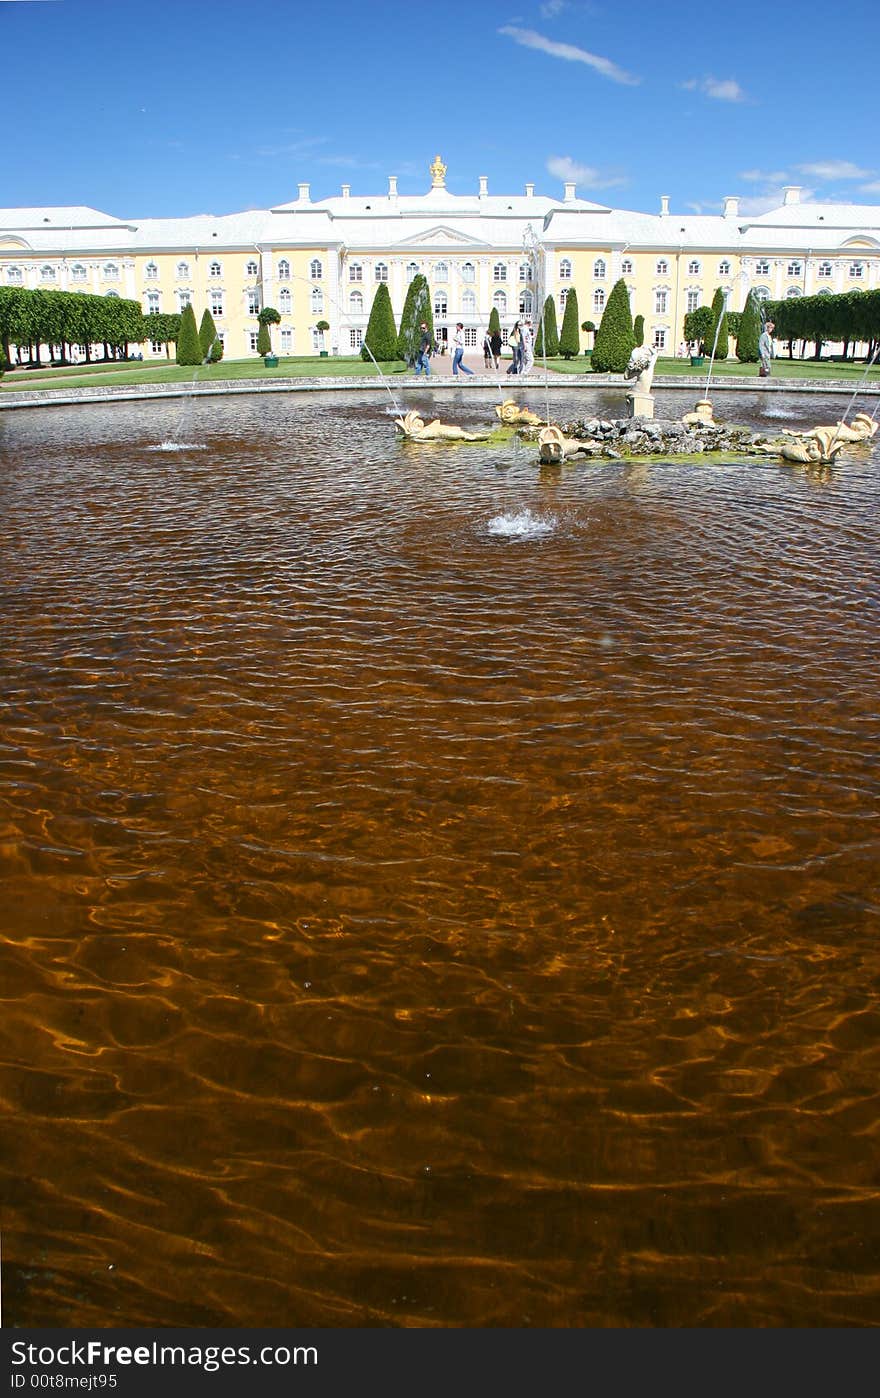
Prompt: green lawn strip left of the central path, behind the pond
<box><xmin>0</xmin><ymin>355</ymin><xmax>409</xmax><ymax>393</ymax></box>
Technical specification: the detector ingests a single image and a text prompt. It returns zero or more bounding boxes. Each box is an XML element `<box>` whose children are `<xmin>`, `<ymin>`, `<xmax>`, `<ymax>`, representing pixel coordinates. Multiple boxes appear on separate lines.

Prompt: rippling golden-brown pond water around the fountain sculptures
<box><xmin>0</xmin><ymin>390</ymin><xmax>880</xmax><ymax>1327</ymax></box>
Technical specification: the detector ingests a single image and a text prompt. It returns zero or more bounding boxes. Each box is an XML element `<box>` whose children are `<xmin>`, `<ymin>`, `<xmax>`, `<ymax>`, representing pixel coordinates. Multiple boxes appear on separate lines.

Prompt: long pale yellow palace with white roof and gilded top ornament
<box><xmin>0</xmin><ymin>155</ymin><xmax>880</xmax><ymax>359</ymax></box>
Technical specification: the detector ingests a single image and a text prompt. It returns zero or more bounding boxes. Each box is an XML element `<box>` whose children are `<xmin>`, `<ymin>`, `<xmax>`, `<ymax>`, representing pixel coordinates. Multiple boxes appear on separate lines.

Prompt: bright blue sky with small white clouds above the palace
<box><xmin>0</xmin><ymin>0</ymin><xmax>880</xmax><ymax>218</ymax></box>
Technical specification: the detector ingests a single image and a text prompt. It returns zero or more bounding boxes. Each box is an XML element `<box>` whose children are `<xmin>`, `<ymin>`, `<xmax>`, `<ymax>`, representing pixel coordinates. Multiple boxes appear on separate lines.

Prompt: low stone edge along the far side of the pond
<box><xmin>0</xmin><ymin>373</ymin><xmax>880</xmax><ymax>410</ymax></box>
